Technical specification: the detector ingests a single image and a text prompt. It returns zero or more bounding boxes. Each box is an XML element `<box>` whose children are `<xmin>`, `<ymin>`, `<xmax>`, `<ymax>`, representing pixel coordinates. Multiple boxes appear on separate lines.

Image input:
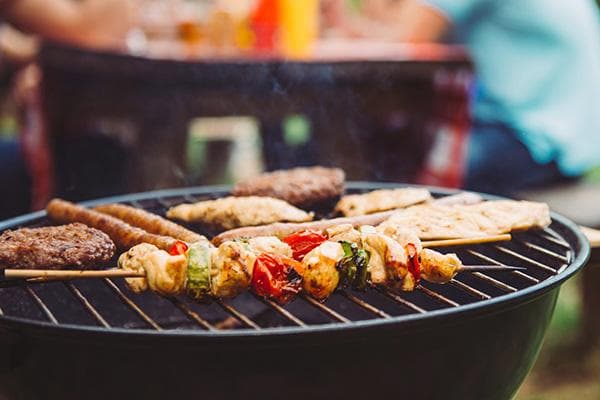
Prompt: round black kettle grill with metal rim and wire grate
<box><xmin>0</xmin><ymin>183</ymin><xmax>589</xmax><ymax>399</ymax></box>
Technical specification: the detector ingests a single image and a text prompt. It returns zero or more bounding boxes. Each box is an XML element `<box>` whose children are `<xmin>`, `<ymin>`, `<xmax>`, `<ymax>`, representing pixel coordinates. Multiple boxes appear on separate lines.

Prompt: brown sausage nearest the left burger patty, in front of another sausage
<box><xmin>46</xmin><ymin>199</ymin><xmax>176</xmax><ymax>250</ymax></box>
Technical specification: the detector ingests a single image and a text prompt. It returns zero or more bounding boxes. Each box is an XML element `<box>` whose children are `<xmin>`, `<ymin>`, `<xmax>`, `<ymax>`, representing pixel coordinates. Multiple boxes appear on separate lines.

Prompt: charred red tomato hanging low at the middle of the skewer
<box><xmin>251</xmin><ymin>253</ymin><xmax>302</xmax><ymax>304</ymax></box>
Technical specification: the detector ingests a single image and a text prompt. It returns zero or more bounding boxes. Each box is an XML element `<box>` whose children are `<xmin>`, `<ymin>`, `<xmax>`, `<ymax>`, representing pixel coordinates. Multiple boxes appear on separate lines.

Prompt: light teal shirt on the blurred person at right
<box><xmin>421</xmin><ymin>0</ymin><xmax>600</xmax><ymax>175</ymax></box>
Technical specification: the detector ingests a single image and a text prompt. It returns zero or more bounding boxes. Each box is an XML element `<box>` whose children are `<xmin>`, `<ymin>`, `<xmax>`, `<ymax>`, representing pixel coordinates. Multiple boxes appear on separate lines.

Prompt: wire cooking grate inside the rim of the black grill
<box><xmin>0</xmin><ymin>185</ymin><xmax>575</xmax><ymax>331</ymax></box>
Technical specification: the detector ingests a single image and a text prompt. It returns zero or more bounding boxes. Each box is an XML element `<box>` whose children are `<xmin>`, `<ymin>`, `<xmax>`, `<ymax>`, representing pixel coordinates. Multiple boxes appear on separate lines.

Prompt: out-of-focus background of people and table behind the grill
<box><xmin>0</xmin><ymin>0</ymin><xmax>600</xmax><ymax>400</ymax></box>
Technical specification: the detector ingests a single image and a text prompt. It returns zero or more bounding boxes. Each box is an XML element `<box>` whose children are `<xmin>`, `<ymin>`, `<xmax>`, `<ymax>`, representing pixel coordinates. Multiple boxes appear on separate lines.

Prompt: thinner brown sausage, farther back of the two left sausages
<box><xmin>94</xmin><ymin>204</ymin><xmax>208</xmax><ymax>243</ymax></box>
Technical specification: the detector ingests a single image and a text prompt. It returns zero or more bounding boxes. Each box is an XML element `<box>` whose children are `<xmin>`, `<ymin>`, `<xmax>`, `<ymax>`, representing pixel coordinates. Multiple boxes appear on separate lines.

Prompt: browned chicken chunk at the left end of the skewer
<box><xmin>119</xmin><ymin>243</ymin><xmax>188</xmax><ymax>296</ymax></box>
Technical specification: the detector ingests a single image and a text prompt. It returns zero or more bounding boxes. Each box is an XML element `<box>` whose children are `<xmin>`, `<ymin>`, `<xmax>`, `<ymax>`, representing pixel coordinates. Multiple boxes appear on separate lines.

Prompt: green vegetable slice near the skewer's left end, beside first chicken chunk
<box><xmin>187</xmin><ymin>243</ymin><xmax>216</xmax><ymax>300</ymax></box>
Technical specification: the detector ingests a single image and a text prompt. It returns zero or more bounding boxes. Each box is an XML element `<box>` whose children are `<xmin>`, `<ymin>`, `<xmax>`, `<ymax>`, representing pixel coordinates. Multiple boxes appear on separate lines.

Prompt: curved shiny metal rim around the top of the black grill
<box><xmin>0</xmin><ymin>181</ymin><xmax>590</xmax><ymax>340</ymax></box>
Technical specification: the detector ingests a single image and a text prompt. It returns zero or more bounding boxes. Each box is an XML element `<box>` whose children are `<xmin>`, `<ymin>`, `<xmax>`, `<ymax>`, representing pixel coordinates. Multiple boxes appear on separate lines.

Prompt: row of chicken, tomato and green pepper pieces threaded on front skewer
<box><xmin>118</xmin><ymin>225</ymin><xmax>488</xmax><ymax>303</ymax></box>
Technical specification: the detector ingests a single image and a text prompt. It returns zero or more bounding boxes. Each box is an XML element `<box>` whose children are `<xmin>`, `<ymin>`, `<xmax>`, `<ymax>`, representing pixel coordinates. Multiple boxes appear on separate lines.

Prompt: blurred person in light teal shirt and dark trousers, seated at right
<box><xmin>325</xmin><ymin>0</ymin><xmax>600</xmax><ymax>195</ymax></box>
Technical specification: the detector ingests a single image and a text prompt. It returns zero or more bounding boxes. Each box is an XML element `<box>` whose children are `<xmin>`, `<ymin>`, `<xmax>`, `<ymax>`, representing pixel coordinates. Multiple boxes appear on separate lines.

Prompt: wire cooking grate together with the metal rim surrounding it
<box><xmin>0</xmin><ymin>182</ymin><xmax>589</xmax><ymax>337</ymax></box>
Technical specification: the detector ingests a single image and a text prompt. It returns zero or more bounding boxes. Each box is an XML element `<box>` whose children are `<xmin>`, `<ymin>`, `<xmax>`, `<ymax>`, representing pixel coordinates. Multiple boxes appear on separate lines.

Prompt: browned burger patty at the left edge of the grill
<box><xmin>0</xmin><ymin>223</ymin><xmax>116</xmax><ymax>269</ymax></box>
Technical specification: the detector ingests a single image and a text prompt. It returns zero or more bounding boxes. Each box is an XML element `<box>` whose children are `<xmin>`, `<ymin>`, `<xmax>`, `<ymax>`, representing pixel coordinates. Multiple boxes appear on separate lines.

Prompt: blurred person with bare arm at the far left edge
<box><xmin>0</xmin><ymin>0</ymin><xmax>138</xmax><ymax>219</ymax></box>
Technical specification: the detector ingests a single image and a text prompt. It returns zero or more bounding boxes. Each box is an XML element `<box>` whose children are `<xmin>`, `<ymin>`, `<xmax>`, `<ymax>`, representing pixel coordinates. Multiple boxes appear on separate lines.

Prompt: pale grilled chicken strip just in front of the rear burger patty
<box><xmin>167</xmin><ymin>196</ymin><xmax>313</xmax><ymax>229</ymax></box>
